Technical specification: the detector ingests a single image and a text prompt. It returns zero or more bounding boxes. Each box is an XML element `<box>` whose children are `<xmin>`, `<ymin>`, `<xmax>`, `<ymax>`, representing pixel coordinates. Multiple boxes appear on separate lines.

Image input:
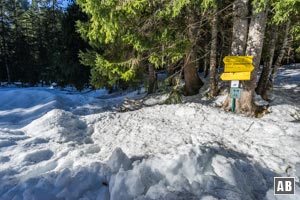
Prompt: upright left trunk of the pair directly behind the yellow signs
<box><xmin>223</xmin><ymin>0</ymin><xmax>249</xmax><ymax>110</ymax></box>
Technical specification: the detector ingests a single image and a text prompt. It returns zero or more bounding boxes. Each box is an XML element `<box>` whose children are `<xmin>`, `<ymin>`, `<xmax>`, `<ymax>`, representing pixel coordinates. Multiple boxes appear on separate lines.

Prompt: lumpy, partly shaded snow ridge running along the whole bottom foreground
<box><xmin>0</xmin><ymin>144</ymin><xmax>300</xmax><ymax>200</ymax></box>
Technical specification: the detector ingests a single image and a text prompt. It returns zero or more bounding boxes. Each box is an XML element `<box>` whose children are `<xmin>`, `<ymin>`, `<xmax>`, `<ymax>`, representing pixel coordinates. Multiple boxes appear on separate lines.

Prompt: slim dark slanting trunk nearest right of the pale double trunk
<box><xmin>256</xmin><ymin>25</ymin><xmax>278</xmax><ymax>100</ymax></box>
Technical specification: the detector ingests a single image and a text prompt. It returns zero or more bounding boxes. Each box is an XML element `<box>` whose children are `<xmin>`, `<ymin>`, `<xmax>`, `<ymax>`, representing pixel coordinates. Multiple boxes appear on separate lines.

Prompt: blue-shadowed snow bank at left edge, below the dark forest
<box><xmin>0</xmin><ymin>87</ymin><xmax>116</xmax><ymax>127</ymax></box>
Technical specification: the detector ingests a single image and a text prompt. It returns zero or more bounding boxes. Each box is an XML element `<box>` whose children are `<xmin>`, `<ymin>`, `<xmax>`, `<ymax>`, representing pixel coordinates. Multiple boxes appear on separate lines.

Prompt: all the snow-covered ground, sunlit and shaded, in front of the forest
<box><xmin>0</xmin><ymin>67</ymin><xmax>300</xmax><ymax>200</ymax></box>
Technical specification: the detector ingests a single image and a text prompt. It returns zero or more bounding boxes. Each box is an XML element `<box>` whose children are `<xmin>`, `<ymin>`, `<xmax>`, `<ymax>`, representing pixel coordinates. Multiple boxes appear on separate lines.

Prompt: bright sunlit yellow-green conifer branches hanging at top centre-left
<box><xmin>77</xmin><ymin>0</ymin><xmax>205</xmax><ymax>87</ymax></box>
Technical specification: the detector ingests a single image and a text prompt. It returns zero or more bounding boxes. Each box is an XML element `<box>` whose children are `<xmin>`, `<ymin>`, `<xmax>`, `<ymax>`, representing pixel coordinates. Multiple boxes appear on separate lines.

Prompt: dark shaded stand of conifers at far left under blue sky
<box><xmin>0</xmin><ymin>0</ymin><xmax>90</xmax><ymax>89</ymax></box>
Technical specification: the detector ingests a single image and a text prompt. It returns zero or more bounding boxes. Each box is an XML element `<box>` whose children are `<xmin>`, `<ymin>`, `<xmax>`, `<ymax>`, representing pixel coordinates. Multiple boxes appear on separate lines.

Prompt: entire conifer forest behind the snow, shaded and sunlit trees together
<box><xmin>0</xmin><ymin>0</ymin><xmax>300</xmax><ymax>115</ymax></box>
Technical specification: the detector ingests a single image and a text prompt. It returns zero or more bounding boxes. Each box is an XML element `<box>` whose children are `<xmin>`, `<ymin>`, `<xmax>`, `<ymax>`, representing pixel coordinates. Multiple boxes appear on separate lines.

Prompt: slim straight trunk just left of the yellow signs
<box><xmin>209</xmin><ymin>8</ymin><xmax>218</xmax><ymax>97</ymax></box>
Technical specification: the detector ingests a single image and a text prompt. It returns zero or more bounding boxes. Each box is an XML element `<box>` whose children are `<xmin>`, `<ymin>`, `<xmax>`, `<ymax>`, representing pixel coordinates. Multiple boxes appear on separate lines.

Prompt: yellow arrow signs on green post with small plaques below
<box><xmin>221</xmin><ymin>56</ymin><xmax>254</xmax><ymax>112</ymax></box>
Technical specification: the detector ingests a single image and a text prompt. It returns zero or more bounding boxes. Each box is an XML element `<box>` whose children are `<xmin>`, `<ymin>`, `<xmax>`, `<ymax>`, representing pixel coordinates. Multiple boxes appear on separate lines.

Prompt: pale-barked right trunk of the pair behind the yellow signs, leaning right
<box><xmin>236</xmin><ymin>8</ymin><xmax>267</xmax><ymax>116</ymax></box>
